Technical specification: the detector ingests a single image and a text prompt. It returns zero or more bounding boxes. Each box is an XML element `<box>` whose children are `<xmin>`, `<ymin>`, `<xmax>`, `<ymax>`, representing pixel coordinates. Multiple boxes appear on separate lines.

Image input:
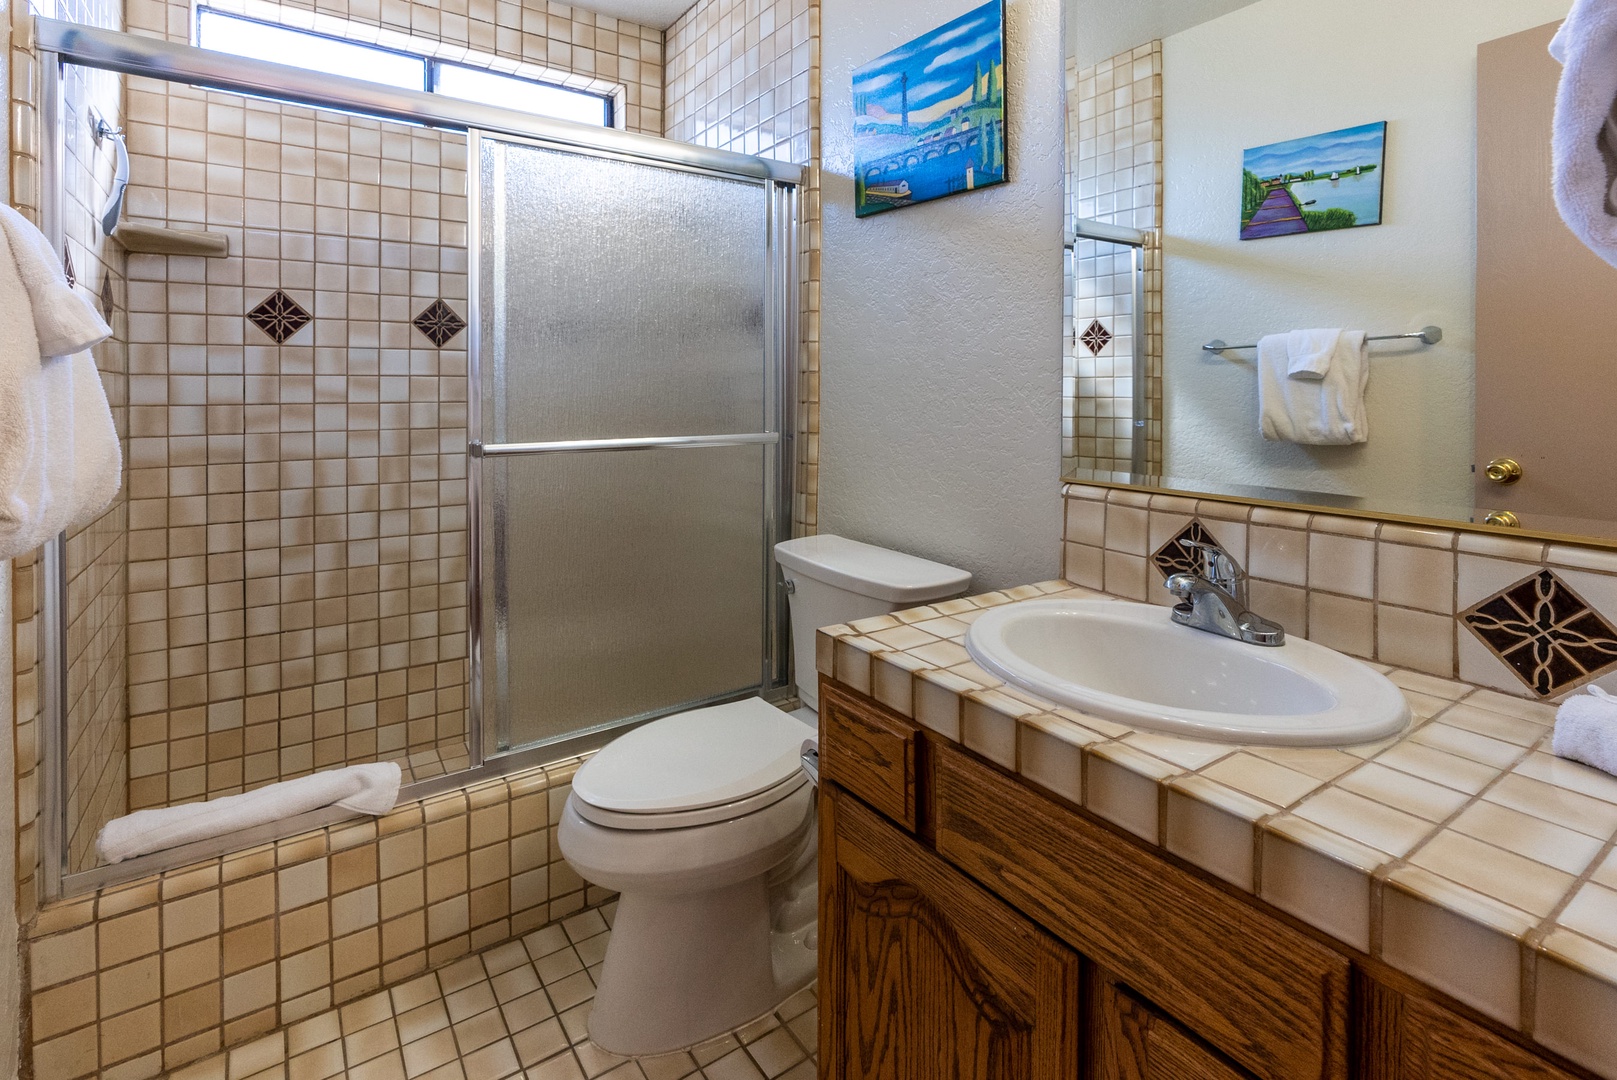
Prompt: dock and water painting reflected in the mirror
<box><xmin>1240</xmin><ymin>121</ymin><xmax>1387</xmax><ymax>239</ymax></box>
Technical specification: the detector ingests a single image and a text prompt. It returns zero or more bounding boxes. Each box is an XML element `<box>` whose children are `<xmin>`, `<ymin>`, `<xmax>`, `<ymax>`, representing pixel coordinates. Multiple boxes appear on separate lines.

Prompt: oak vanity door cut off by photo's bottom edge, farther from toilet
<box><xmin>1087</xmin><ymin>970</ymin><xmax>1252</xmax><ymax>1080</ymax></box>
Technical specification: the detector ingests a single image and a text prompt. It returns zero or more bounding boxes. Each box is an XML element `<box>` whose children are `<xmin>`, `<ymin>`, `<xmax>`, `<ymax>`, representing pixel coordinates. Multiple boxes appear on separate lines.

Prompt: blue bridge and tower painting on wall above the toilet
<box><xmin>854</xmin><ymin>0</ymin><xmax>1006</xmax><ymax>217</ymax></box>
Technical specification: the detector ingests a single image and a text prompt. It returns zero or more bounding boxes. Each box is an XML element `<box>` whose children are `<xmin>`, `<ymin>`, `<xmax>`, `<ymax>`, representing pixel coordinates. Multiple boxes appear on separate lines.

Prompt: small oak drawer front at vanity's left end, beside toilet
<box><xmin>820</xmin><ymin>681</ymin><xmax>915</xmax><ymax>833</ymax></box>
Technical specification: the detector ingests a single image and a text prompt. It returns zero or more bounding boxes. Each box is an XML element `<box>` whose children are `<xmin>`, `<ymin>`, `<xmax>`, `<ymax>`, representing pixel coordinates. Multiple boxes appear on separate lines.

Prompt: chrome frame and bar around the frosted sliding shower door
<box><xmin>466</xmin><ymin>131</ymin><xmax>800</xmax><ymax>768</ymax></box>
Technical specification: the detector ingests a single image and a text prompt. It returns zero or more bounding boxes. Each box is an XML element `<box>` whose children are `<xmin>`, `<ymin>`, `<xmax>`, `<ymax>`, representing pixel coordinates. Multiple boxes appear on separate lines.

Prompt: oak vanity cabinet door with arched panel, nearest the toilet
<box><xmin>820</xmin><ymin>786</ymin><xmax>1080</xmax><ymax>1080</ymax></box>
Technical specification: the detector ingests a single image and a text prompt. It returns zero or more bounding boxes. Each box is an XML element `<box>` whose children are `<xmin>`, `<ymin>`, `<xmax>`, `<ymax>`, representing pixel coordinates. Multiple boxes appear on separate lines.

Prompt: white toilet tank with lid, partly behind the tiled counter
<box><xmin>775</xmin><ymin>537</ymin><xmax>972</xmax><ymax>711</ymax></box>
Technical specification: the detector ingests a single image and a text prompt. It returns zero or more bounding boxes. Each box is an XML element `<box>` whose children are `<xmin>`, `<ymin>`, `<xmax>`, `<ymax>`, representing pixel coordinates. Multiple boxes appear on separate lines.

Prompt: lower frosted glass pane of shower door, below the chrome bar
<box><xmin>483</xmin><ymin>446</ymin><xmax>771</xmax><ymax>753</ymax></box>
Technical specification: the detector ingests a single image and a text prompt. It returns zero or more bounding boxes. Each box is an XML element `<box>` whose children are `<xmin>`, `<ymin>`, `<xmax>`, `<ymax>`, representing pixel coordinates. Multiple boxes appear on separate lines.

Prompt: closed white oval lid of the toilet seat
<box><xmin>572</xmin><ymin>697</ymin><xmax>815</xmax><ymax>813</ymax></box>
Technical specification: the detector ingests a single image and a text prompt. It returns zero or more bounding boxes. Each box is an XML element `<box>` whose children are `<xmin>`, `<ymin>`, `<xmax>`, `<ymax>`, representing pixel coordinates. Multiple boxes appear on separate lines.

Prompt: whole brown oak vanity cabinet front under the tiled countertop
<box><xmin>820</xmin><ymin>679</ymin><xmax>1590</xmax><ymax>1080</ymax></box>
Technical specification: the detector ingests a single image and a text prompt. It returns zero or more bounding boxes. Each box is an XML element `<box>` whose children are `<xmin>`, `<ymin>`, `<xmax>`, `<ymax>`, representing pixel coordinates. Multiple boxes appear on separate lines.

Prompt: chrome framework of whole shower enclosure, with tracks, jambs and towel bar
<box><xmin>32</xmin><ymin>16</ymin><xmax>804</xmax><ymax>902</ymax></box>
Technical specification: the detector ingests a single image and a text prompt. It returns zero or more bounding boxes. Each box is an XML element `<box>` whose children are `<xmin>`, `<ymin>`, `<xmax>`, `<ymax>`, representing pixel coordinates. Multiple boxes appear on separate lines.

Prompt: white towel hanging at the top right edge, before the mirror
<box><xmin>1549</xmin><ymin>0</ymin><xmax>1617</xmax><ymax>267</ymax></box>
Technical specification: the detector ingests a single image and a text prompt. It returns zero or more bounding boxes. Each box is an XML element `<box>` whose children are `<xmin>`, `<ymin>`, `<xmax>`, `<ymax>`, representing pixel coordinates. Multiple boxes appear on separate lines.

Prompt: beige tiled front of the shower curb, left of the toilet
<box><xmin>27</xmin><ymin>760</ymin><xmax>610</xmax><ymax>1080</ymax></box>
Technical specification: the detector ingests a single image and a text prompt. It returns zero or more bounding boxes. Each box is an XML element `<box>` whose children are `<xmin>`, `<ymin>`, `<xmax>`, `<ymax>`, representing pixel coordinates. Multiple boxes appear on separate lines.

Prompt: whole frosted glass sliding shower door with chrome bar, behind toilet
<box><xmin>471</xmin><ymin>136</ymin><xmax>791</xmax><ymax>757</ymax></box>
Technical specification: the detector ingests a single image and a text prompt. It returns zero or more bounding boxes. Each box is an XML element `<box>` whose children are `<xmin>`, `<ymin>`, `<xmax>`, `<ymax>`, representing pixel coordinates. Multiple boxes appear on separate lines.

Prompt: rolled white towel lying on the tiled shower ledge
<box><xmin>95</xmin><ymin>761</ymin><xmax>403</xmax><ymax>863</ymax></box>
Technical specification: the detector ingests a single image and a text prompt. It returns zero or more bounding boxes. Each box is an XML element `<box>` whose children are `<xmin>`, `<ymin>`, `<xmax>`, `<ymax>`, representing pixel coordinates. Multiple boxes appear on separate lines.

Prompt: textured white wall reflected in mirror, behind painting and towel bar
<box><xmin>1163</xmin><ymin>0</ymin><xmax>1568</xmax><ymax>517</ymax></box>
